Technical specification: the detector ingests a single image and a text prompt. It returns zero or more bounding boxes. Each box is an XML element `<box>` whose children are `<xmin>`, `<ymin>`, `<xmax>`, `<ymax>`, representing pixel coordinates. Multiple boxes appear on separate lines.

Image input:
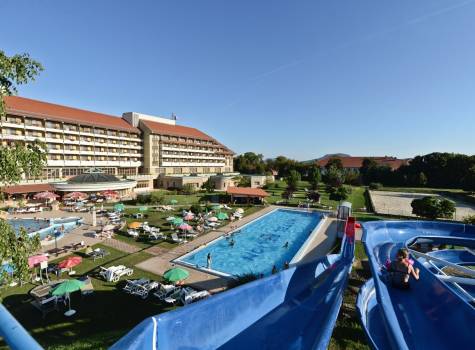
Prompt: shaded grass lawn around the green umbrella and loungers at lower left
<box><xmin>0</xmin><ymin>244</ymin><xmax>173</xmax><ymax>349</ymax></box>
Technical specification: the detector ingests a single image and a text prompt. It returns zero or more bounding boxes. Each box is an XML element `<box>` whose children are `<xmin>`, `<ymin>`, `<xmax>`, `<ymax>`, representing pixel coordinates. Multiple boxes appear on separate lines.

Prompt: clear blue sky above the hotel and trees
<box><xmin>0</xmin><ymin>0</ymin><xmax>475</xmax><ymax>160</ymax></box>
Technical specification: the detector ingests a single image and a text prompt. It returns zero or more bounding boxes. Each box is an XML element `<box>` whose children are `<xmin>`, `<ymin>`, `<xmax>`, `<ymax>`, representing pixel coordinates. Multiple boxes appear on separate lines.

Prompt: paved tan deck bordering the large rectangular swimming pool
<box><xmin>136</xmin><ymin>206</ymin><xmax>337</xmax><ymax>292</ymax></box>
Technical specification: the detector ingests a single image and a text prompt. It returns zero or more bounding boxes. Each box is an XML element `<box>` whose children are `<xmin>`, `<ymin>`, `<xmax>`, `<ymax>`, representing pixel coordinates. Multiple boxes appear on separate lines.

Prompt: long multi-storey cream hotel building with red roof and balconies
<box><xmin>0</xmin><ymin>96</ymin><xmax>233</xmax><ymax>191</ymax></box>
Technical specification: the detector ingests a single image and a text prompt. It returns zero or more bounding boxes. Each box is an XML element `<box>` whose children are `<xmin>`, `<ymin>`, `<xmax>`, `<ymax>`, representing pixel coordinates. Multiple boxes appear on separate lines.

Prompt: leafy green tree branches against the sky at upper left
<box><xmin>0</xmin><ymin>50</ymin><xmax>43</xmax><ymax>116</ymax></box>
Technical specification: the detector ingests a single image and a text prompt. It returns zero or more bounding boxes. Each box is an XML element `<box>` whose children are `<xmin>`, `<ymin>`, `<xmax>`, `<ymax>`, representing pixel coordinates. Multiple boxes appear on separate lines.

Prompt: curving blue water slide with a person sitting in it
<box><xmin>357</xmin><ymin>221</ymin><xmax>475</xmax><ymax>350</ymax></box>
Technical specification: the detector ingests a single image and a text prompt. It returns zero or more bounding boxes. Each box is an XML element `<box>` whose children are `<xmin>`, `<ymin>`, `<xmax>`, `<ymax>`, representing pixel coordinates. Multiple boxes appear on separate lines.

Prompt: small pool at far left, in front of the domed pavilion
<box><xmin>8</xmin><ymin>217</ymin><xmax>83</xmax><ymax>240</ymax></box>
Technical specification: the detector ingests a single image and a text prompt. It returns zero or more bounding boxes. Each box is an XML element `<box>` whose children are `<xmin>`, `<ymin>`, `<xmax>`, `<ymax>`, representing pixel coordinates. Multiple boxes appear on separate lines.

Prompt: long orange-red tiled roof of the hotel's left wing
<box><xmin>4</xmin><ymin>96</ymin><xmax>140</xmax><ymax>133</ymax></box>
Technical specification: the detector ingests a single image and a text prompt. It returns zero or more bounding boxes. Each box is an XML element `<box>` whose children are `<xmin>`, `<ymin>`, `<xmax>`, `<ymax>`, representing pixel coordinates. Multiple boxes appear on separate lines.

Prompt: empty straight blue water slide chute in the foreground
<box><xmin>111</xmin><ymin>228</ymin><xmax>354</xmax><ymax>350</ymax></box>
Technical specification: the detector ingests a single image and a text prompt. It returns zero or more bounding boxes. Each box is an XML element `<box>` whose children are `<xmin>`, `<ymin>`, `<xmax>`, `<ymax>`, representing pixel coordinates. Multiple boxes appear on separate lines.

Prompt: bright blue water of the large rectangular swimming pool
<box><xmin>177</xmin><ymin>209</ymin><xmax>323</xmax><ymax>276</ymax></box>
